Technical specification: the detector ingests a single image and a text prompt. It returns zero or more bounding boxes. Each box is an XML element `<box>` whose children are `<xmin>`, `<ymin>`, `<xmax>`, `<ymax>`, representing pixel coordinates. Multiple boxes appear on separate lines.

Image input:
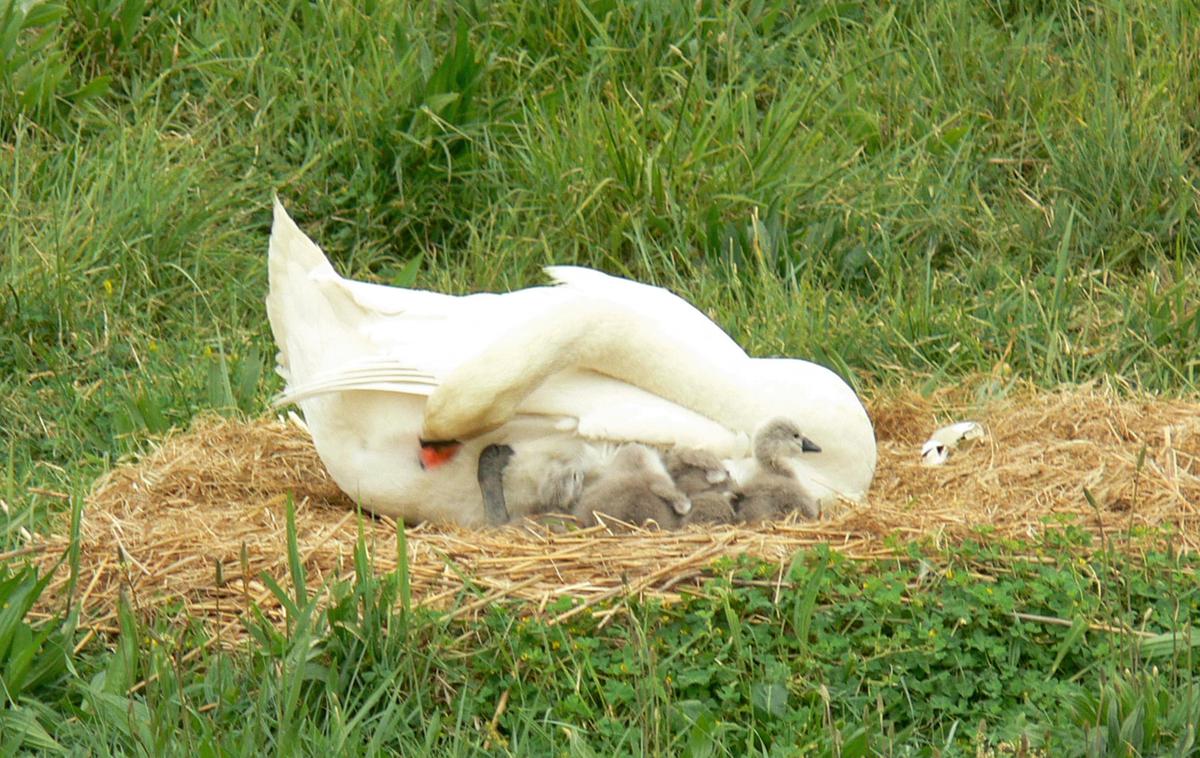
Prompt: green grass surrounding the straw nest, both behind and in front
<box><xmin>0</xmin><ymin>0</ymin><xmax>1200</xmax><ymax>756</ymax></box>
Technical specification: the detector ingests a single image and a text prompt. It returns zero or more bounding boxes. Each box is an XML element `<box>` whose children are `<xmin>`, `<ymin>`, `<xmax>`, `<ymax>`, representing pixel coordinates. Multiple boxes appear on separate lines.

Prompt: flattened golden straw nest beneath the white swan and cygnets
<box><xmin>23</xmin><ymin>381</ymin><xmax>1200</xmax><ymax>631</ymax></box>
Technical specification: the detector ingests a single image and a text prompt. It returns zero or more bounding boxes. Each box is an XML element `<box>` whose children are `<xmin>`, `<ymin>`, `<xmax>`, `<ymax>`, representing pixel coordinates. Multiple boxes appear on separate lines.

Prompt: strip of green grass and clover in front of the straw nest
<box><xmin>0</xmin><ymin>533</ymin><xmax>1200</xmax><ymax>756</ymax></box>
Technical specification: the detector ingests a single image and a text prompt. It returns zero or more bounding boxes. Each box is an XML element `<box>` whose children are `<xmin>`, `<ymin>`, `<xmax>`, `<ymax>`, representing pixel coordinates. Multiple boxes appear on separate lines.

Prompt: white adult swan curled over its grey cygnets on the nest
<box><xmin>266</xmin><ymin>200</ymin><xmax>876</xmax><ymax>525</ymax></box>
